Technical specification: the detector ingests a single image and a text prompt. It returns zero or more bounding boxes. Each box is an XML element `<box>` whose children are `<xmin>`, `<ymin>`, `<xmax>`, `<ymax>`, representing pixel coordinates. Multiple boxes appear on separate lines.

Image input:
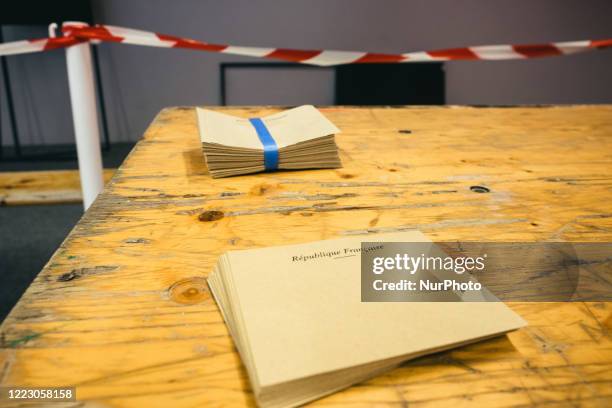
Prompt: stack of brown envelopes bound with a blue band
<box><xmin>197</xmin><ymin>105</ymin><xmax>342</xmax><ymax>178</ymax></box>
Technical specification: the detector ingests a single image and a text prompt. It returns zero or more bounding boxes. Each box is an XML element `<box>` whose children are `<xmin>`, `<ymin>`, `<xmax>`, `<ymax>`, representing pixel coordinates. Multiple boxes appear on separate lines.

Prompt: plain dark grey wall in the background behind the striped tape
<box><xmin>2</xmin><ymin>0</ymin><xmax>612</xmax><ymax>144</ymax></box>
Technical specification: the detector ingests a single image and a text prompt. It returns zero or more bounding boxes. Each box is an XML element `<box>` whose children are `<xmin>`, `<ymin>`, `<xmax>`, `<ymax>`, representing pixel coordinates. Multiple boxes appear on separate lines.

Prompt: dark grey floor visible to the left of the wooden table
<box><xmin>0</xmin><ymin>144</ymin><xmax>133</xmax><ymax>321</ymax></box>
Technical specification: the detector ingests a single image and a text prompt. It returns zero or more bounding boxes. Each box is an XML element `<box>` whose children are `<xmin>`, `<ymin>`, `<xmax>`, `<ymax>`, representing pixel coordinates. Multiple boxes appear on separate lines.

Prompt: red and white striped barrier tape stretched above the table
<box><xmin>0</xmin><ymin>23</ymin><xmax>612</xmax><ymax>66</ymax></box>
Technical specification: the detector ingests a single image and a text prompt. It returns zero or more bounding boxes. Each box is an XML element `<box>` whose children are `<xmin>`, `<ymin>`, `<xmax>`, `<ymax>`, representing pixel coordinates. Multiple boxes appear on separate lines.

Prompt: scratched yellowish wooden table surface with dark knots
<box><xmin>0</xmin><ymin>106</ymin><xmax>612</xmax><ymax>408</ymax></box>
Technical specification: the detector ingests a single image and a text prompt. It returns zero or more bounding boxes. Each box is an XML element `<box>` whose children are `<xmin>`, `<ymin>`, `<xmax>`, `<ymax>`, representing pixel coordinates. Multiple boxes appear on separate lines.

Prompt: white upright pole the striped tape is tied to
<box><xmin>66</xmin><ymin>22</ymin><xmax>104</xmax><ymax>210</ymax></box>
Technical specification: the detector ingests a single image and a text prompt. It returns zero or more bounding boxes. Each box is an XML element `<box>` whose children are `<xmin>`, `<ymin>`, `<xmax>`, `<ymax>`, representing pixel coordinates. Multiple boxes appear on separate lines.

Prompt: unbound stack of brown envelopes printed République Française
<box><xmin>208</xmin><ymin>231</ymin><xmax>525</xmax><ymax>407</ymax></box>
